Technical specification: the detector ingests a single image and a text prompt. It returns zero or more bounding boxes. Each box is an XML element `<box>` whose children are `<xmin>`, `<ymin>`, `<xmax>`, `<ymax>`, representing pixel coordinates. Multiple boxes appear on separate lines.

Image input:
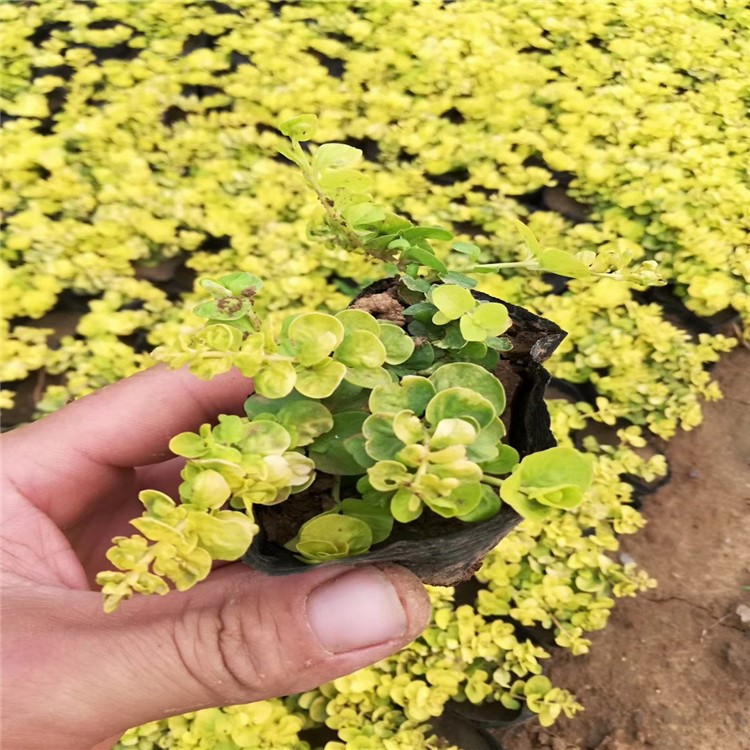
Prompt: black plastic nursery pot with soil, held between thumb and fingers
<box><xmin>243</xmin><ymin>279</ymin><xmax>566</xmax><ymax>586</ymax></box>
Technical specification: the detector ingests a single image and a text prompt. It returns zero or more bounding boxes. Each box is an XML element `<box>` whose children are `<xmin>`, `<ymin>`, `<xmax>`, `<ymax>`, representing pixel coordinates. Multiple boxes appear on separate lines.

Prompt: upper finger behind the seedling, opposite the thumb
<box><xmin>3</xmin><ymin>366</ymin><xmax>252</xmax><ymax>528</ymax></box>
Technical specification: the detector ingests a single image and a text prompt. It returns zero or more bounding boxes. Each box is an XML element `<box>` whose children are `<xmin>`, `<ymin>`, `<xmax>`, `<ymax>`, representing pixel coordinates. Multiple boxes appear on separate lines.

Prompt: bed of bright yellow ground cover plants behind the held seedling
<box><xmin>0</xmin><ymin>0</ymin><xmax>750</xmax><ymax>750</ymax></box>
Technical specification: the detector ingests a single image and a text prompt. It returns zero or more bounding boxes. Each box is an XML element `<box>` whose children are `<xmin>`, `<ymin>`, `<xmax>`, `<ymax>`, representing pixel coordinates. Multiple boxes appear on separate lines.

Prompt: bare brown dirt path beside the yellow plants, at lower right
<box><xmin>500</xmin><ymin>349</ymin><xmax>750</xmax><ymax>750</ymax></box>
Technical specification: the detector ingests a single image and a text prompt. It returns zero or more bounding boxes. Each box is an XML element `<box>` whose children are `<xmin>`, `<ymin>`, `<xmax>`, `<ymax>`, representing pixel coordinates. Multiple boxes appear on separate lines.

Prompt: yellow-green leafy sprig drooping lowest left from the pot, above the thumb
<box><xmin>97</xmin><ymin>414</ymin><xmax>325</xmax><ymax>612</ymax></box>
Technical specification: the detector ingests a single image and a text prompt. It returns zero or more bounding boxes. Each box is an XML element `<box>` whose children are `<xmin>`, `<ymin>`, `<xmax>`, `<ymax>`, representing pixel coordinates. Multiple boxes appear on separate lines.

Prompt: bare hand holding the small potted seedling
<box><xmin>0</xmin><ymin>366</ymin><xmax>430</xmax><ymax>750</ymax></box>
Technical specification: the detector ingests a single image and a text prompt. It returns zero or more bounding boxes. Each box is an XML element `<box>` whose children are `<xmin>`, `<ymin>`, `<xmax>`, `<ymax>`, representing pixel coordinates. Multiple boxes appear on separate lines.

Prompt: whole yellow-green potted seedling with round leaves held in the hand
<box><xmin>97</xmin><ymin>115</ymin><xmax>654</xmax><ymax>612</ymax></box>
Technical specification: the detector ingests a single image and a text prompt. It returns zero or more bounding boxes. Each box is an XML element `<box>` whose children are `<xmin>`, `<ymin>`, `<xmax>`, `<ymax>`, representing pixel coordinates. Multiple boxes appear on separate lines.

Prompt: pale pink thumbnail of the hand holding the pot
<box><xmin>307</xmin><ymin>568</ymin><xmax>408</xmax><ymax>654</ymax></box>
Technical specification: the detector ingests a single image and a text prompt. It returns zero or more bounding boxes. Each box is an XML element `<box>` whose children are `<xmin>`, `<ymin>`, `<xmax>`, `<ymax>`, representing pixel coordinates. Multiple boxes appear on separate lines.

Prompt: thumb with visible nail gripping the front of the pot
<box><xmin>7</xmin><ymin>565</ymin><xmax>430</xmax><ymax>747</ymax></box>
